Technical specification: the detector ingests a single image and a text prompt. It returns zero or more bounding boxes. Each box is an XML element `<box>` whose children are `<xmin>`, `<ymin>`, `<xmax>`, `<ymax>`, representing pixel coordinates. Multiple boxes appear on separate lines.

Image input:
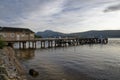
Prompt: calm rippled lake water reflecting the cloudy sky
<box><xmin>16</xmin><ymin>39</ymin><xmax>120</xmax><ymax>80</ymax></box>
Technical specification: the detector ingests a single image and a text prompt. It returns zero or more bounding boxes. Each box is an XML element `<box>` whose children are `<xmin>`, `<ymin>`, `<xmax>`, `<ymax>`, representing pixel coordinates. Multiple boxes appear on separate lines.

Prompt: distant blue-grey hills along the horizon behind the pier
<box><xmin>36</xmin><ymin>30</ymin><xmax>120</xmax><ymax>38</ymax></box>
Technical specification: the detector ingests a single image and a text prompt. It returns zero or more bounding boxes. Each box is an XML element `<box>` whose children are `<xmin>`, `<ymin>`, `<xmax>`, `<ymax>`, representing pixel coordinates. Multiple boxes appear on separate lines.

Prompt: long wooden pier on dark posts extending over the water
<box><xmin>5</xmin><ymin>38</ymin><xmax>108</xmax><ymax>49</ymax></box>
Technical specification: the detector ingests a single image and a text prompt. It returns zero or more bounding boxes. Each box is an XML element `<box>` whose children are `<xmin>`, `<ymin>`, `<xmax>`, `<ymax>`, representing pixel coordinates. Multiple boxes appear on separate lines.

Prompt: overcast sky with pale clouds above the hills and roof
<box><xmin>0</xmin><ymin>0</ymin><xmax>120</xmax><ymax>33</ymax></box>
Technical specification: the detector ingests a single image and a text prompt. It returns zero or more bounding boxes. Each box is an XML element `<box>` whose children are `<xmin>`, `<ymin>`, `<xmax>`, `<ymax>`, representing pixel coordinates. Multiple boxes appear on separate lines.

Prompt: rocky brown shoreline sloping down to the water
<box><xmin>0</xmin><ymin>47</ymin><xmax>27</xmax><ymax>80</ymax></box>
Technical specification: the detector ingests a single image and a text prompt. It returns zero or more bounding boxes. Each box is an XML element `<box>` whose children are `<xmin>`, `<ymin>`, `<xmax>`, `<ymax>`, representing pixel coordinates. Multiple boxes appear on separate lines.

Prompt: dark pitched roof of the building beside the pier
<box><xmin>0</xmin><ymin>27</ymin><xmax>34</xmax><ymax>33</ymax></box>
